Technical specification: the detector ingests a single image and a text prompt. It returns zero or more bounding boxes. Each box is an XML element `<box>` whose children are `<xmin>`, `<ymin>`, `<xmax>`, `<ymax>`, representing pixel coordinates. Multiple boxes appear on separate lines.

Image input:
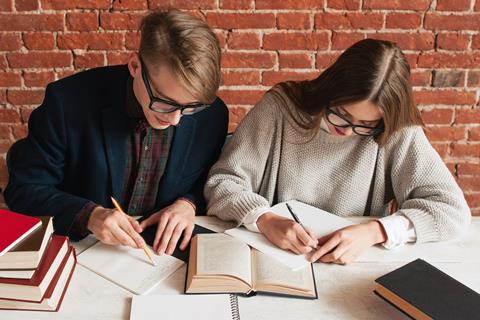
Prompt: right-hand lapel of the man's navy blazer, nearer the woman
<box><xmin>157</xmin><ymin>116</ymin><xmax>197</xmax><ymax>207</ymax></box>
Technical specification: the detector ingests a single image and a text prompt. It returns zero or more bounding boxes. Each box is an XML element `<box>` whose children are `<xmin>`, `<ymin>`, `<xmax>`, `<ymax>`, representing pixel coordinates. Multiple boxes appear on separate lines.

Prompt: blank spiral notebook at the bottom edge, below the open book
<box><xmin>130</xmin><ymin>294</ymin><xmax>240</xmax><ymax>320</ymax></box>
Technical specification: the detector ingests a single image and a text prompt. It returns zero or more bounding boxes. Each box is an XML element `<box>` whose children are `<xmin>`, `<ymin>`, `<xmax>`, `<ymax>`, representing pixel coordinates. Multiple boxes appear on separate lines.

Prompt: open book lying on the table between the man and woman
<box><xmin>185</xmin><ymin>233</ymin><xmax>317</xmax><ymax>299</ymax></box>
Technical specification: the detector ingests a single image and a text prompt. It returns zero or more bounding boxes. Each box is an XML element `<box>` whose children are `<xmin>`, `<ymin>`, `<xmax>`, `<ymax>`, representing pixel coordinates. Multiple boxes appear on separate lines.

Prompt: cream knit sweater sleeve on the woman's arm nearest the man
<box><xmin>204</xmin><ymin>93</ymin><xmax>280</xmax><ymax>225</ymax></box>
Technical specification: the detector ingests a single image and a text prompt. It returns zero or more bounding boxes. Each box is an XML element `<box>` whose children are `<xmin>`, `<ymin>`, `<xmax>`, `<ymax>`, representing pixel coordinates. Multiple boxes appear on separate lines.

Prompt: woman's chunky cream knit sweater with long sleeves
<box><xmin>204</xmin><ymin>88</ymin><xmax>471</xmax><ymax>242</ymax></box>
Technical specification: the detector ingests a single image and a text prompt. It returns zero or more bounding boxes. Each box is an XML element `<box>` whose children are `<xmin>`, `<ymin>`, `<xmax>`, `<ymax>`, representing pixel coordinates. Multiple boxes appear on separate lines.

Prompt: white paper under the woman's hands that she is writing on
<box><xmin>225</xmin><ymin>200</ymin><xmax>353</xmax><ymax>270</ymax></box>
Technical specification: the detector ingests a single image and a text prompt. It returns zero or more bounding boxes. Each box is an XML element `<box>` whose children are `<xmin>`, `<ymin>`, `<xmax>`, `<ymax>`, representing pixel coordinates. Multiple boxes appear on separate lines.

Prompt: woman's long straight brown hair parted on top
<box><xmin>272</xmin><ymin>39</ymin><xmax>424</xmax><ymax>145</ymax></box>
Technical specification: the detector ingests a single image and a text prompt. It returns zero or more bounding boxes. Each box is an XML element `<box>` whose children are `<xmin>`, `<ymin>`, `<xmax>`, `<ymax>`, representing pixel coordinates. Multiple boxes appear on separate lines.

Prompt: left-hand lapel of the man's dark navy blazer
<box><xmin>102</xmin><ymin>106</ymin><xmax>130</xmax><ymax>199</ymax></box>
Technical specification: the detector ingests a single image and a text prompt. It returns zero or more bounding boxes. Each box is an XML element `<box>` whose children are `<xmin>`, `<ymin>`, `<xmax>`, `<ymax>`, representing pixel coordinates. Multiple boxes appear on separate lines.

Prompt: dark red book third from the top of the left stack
<box><xmin>0</xmin><ymin>235</ymin><xmax>70</xmax><ymax>302</ymax></box>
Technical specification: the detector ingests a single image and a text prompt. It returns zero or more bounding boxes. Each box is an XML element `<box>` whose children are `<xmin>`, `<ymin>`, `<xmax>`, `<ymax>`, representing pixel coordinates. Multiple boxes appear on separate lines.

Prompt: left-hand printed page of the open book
<box><xmin>197</xmin><ymin>233</ymin><xmax>251</xmax><ymax>284</ymax></box>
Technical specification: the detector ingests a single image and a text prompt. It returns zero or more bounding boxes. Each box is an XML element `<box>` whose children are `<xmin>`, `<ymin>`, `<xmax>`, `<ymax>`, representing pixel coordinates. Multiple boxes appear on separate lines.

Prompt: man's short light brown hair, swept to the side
<box><xmin>139</xmin><ymin>10</ymin><xmax>221</xmax><ymax>102</ymax></box>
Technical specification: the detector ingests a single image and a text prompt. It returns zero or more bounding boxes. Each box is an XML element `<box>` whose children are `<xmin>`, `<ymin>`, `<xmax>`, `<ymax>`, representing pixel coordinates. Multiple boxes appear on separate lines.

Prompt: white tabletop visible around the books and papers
<box><xmin>0</xmin><ymin>217</ymin><xmax>480</xmax><ymax>320</ymax></box>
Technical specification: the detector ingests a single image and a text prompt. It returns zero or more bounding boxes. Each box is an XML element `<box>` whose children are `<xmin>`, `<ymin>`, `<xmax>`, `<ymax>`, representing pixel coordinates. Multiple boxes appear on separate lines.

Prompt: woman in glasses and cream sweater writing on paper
<box><xmin>204</xmin><ymin>39</ymin><xmax>471</xmax><ymax>264</ymax></box>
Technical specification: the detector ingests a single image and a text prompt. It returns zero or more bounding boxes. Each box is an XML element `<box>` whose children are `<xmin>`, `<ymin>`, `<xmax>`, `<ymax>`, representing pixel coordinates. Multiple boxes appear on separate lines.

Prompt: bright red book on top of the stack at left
<box><xmin>0</xmin><ymin>210</ymin><xmax>42</xmax><ymax>256</ymax></box>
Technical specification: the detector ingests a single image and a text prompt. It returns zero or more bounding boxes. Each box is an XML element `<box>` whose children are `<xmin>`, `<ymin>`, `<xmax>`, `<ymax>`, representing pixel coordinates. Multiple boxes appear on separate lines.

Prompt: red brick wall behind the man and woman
<box><xmin>0</xmin><ymin>0</ymin><xmax>480</xmax><ymax>215</ymax></box>
